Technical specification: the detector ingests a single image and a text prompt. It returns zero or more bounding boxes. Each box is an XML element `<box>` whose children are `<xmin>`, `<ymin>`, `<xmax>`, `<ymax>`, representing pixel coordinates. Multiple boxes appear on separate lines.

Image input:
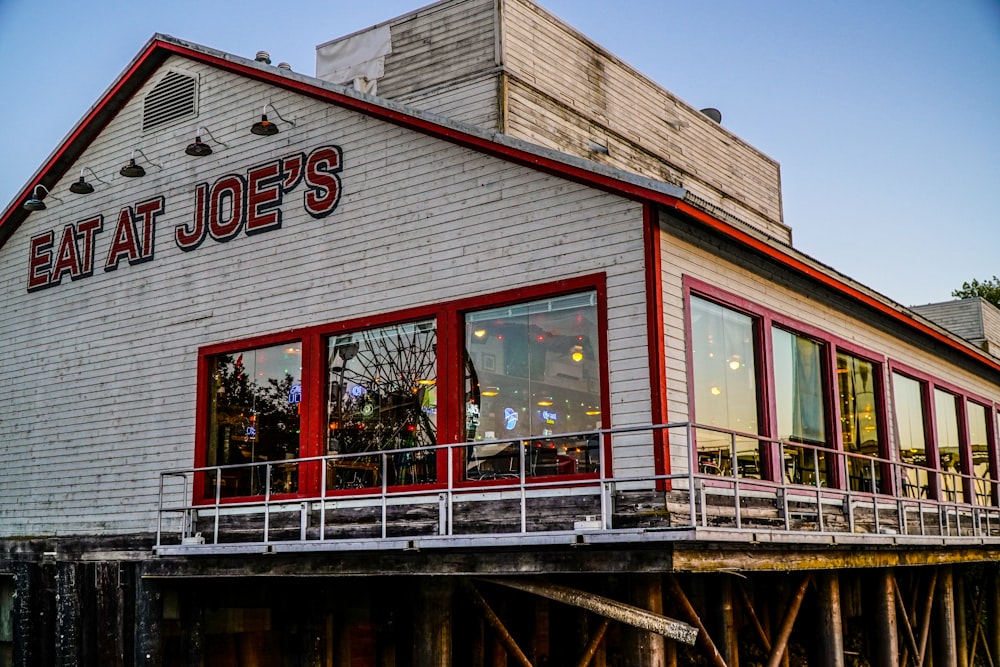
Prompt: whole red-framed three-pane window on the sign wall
<box><xmin>195</xmin><ymin>275</ymin><xmax>607</xmax><ymax>500</ymax></box>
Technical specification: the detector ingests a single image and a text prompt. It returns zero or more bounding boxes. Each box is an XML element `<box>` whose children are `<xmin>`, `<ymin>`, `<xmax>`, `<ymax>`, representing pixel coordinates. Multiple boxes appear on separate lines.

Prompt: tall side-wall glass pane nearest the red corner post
<box><xmin>691</xmin><ymin>297</ymin><xmax>763</xmax><ymax>478</ymax></box>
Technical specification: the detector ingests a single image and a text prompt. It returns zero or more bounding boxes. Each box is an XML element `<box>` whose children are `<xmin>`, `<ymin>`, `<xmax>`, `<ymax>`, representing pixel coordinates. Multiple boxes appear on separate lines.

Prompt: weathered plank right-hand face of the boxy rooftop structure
<box><xmin>501</xmin><ymin>0</ymin><xmax>791</xmax><ymax>242</ymax></box>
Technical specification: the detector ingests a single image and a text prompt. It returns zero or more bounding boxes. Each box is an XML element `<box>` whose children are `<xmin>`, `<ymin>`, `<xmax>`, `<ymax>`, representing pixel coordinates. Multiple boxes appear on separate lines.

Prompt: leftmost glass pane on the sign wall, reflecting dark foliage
<box><xmin>206</xmin><ymin>342</ymin><xmax>302</xmax><ymax>497</ymax></box>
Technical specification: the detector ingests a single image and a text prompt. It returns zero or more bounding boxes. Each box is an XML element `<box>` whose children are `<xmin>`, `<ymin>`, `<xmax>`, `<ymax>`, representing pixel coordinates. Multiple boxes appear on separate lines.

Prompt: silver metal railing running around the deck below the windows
<box><xmin>156</xmin><ymin>423</ymin><xmax>1000</xmax><ymax>553</ymax></box>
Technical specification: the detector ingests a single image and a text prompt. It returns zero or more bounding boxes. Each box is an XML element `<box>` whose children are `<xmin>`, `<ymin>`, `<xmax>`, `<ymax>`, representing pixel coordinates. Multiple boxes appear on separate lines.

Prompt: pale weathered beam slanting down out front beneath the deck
<box><xmin>483</xmin><ymin>578</ymin><xmax>698</xmax><ymax>645</ymax></box>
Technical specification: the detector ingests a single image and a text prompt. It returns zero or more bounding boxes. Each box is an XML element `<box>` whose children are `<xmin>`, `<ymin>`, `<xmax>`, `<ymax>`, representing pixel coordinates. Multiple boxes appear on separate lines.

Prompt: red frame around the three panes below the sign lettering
<box><xmin>193</xmin><ymin>273</ymin><xmax>611</xmax><ymax>503</ymax></box>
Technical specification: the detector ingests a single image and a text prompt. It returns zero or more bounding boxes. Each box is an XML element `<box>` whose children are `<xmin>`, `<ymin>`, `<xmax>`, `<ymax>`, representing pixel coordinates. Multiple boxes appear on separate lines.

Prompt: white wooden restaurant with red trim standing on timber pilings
<box><xmin>0</xmin><ymin>0</ymin><xmax>1000</xmax><ymax>667</ymax></box>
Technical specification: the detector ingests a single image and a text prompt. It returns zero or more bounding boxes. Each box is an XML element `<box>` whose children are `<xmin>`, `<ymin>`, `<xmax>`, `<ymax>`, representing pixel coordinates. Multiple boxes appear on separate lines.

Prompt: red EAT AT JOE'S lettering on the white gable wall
<box><xmin>28</xmin><ymin>146</ymin><xmax>343</xmax><ymax>292</ymax></box>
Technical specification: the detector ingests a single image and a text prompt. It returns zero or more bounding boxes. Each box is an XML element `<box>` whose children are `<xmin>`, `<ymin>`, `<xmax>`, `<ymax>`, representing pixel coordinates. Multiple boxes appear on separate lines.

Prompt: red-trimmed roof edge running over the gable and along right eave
<box><xmin>0</xmin><ymin>34</ymin><xmax>1000</xmax><ymax>372</ymax></box>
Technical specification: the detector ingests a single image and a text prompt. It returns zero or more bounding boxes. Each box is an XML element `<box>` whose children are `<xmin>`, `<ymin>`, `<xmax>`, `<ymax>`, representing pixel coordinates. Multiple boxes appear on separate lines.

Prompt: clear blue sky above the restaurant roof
<box><xmin>0</xmin><ymin>0</ymin><xmax>1000</xmax><ymax>305</ymax></box>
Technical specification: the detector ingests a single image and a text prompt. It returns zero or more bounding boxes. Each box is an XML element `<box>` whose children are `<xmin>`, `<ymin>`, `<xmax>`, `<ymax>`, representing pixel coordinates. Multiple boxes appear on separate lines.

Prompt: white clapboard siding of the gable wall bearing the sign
<box><xmin>0</xmin><ymin>58</ymin><xmax>649</xmax><ymax>536</ymax></box>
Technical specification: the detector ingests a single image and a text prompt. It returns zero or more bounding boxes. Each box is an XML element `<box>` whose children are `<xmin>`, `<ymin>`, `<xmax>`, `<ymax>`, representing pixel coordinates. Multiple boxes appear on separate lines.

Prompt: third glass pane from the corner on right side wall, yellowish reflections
<box><xmin>837</xmin><ymin>352</ymin><xmax>882</xmax><ymax>491</ymax></box>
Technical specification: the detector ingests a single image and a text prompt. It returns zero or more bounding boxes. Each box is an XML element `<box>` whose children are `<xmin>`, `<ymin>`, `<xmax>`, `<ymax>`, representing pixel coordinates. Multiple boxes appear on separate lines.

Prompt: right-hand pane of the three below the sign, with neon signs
<box><xmin>465</xmin><ymin>292</ymin><xmax>602</xmax><ymax>479</ymax></box>
